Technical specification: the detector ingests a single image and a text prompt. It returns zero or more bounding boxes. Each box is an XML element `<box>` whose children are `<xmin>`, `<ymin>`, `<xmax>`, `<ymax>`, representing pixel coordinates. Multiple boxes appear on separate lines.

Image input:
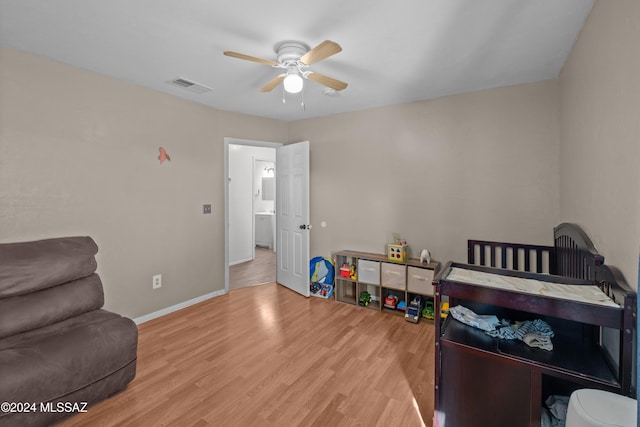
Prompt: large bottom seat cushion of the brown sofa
<box><xmin>0</xmin><ymin>310</ymin><xmax>138</xmax><ymax>402</ymax></box>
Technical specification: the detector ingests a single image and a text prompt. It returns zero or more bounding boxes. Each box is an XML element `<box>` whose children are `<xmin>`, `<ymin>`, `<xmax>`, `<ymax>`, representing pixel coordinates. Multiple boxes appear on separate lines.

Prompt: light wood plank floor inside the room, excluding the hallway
<box><xmin>61</xmin><ymin>283</ymin><xmax>434</xmax><ymax>427</ymax></box>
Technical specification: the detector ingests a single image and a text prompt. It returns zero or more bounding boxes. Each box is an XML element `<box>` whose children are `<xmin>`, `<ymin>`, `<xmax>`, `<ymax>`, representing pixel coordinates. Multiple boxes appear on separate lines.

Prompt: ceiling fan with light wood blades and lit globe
<box><xmin>224</xmin><ymin>40</ymin><xmax>347</xmax><ymax>93</ymax></box>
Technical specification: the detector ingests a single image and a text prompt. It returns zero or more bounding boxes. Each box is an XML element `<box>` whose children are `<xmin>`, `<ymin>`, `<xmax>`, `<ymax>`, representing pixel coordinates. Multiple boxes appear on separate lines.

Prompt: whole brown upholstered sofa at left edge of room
<box><xmin>0</xmin><ymin>237</ymin><xmax>138</xmax><ymax>426</ymax></box>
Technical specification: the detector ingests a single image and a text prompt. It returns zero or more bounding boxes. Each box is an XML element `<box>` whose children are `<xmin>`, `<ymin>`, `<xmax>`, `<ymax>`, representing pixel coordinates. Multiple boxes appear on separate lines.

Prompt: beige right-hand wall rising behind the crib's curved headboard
<box><xmin>560</xmin><ymin>0</ymin><xmax>640</xmax><ymax>288</ymax></box>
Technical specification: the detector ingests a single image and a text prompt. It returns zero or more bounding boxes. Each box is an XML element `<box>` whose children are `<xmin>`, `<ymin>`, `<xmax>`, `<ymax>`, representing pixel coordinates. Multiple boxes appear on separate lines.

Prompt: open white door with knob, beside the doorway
<box><xmin>276</xmin><ymin>141</ymin><xmax>311</xmax><ymax>297</ymax></box>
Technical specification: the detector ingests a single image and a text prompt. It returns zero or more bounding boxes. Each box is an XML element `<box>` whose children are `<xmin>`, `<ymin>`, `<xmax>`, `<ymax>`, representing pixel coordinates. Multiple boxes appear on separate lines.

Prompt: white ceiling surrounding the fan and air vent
<box><xmin>0</xmin><ymin>0</ymin><xmax>595</xmax><ymax>121</ymax></box>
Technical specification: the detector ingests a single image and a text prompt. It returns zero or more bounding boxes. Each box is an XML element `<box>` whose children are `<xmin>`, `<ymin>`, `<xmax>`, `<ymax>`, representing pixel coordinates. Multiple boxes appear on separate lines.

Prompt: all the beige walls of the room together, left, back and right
<box><xmin>7</xmin><ymin>1</ymin><xmax>640</xmax><ymax>317</ymax></box>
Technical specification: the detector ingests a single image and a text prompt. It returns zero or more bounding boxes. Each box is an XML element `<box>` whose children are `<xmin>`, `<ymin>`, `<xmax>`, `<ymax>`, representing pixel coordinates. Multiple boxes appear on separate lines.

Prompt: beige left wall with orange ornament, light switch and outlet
<box><xmin>0</xmin><ymin>48</ymin><xmax>287</xmax><ymax>317</ymax></box>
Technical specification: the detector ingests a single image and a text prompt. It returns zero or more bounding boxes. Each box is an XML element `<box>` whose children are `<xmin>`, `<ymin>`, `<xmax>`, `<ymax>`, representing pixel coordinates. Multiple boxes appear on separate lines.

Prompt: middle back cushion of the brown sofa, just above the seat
<box><xmin>0</xmin><ymin>273</ymin><xmax>104</xmax><ymax>338</ymax></box>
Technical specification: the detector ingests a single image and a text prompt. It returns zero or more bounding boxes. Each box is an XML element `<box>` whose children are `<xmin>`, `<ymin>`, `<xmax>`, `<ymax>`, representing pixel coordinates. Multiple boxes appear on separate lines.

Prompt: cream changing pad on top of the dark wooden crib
<box><xmin>446</xmin><ymin>267</ymin><xmax>620</xmax><ymax>308</ymax></box>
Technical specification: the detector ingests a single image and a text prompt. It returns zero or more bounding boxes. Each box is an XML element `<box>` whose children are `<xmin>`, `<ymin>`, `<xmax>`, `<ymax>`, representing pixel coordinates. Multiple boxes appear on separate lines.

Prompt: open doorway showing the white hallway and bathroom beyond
<box><xmin>224</xmin><ymin>138</ymin><xmax>282</xmax><ymax>291</ymax></box>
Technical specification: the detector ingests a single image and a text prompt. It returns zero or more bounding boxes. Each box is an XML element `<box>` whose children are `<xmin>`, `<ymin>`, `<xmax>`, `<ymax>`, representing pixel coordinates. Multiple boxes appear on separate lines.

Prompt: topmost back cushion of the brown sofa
<box><xmin>0</xmin><ymin>237</ymin><xmax>98</xmax><ymax>298</ymax></box>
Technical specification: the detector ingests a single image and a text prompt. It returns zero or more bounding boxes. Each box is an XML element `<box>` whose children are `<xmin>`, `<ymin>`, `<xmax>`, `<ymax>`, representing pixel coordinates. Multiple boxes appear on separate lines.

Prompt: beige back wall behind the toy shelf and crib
<box><xmin>289</xmin><ymin>81</ymin><xmax>559</xmax><ymax>262</ymax></box>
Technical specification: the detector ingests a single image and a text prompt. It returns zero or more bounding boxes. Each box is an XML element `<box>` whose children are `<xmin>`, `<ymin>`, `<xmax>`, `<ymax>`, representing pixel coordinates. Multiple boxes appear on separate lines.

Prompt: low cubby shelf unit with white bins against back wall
<box><xmin>334</xmin><ymin>250</ymin><xmax>440</xmax><ymax>315</ymax></box>
